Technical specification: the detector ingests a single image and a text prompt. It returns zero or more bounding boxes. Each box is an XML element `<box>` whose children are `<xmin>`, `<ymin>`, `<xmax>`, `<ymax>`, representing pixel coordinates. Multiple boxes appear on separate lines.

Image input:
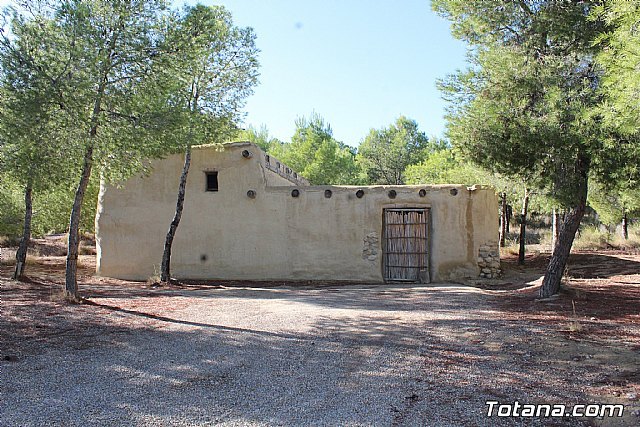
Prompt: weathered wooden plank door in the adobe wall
<box><xmin>383</xmin><ymin>209</ymin><xmax>429</xmax><ymax>282</ymax></box>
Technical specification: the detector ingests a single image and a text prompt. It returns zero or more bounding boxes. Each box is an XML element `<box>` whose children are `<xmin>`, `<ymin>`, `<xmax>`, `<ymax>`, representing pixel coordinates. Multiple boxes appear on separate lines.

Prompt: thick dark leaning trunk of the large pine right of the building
<box><xmin>539</xmin><ymin>166</ymin><xmax>588</xmax><ymax>298</ymax></box>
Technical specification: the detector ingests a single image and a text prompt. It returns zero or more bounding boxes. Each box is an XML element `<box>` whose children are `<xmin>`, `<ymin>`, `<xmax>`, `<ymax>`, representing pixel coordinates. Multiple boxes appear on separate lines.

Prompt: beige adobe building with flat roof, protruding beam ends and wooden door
<box><xmin>96</xmin><ymin>142</ymin><xmax>500</xmax><ymax>283</ymax></box>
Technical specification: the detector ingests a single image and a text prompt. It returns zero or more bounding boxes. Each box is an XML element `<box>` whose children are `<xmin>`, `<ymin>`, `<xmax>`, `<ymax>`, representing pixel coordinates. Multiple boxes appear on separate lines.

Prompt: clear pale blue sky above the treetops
<box><xmin>188</xmin><ymin>0</ymin><xmax>466</xmax><ymax>146</ymax></box>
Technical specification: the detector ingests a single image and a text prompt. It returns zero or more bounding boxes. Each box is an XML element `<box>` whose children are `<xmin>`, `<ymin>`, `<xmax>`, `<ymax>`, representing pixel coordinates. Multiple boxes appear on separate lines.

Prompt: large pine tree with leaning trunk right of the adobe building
<box><xmin>432</xmin><ymin>0</ymin><xmax>640</xmax><ymax>297</ymax></box>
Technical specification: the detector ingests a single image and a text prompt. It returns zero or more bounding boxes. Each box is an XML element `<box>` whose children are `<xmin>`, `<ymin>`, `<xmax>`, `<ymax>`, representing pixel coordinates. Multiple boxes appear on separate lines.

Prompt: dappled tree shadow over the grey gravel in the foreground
<box><xmin>0</xmin><ymin>286</ymin><xmax>616</xmax><ymax>425</ymax></box>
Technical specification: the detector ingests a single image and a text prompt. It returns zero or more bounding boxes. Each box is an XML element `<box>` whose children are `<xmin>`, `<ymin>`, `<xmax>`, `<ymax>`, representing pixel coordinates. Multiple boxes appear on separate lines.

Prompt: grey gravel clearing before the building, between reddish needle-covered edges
<box><xmin>0</xmin><ymin>285</ymin><xmax>638</xmax><ymax>426</ymax></box>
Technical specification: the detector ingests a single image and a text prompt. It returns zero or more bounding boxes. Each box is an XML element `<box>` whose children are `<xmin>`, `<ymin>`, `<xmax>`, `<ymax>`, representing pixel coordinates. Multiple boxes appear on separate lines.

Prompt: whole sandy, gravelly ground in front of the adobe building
<box><xmin>0</xmin><ymin>240</ymin><xmax>640</xmax><ymax>426</ymax></box>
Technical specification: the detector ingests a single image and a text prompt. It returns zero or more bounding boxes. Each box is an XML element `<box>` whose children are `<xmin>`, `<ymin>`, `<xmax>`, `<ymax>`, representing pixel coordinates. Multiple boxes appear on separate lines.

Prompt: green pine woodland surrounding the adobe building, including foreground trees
<box><xmin>0</xmin><ymin>0</ymin><xmax>640</xmax><ymax>296</ymax></box>
